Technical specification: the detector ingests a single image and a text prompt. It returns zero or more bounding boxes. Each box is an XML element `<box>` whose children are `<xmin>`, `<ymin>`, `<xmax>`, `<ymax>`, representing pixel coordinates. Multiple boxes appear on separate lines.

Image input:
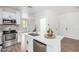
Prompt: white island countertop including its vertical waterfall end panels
<box><xmin>21</xmin><ymin>33</ymin><xmax>63</xmax><ymax>52</ymax></box>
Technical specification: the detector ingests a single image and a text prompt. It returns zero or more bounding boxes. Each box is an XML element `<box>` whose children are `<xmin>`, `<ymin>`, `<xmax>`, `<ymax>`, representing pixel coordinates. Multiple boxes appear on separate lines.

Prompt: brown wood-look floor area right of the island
<box><xmin>61</xmin><ymin>37</ymin><xmax>79</xmax><ymax>52</ymax></box>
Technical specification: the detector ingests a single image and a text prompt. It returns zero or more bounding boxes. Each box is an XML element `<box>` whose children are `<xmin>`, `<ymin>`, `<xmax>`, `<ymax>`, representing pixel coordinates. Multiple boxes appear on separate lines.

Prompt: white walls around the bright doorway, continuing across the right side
<box><xmin>32</xmin><ymin>10</ymin><xmax>79</xmax><ymax>39</ymax></box>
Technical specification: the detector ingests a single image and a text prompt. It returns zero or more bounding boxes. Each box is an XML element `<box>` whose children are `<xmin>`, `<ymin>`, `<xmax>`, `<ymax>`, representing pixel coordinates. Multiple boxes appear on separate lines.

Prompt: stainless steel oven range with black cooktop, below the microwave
<box><xmin>3</xmin><ymin>30</ymin><xmax>17</xmax><ymax>48</ymax></box>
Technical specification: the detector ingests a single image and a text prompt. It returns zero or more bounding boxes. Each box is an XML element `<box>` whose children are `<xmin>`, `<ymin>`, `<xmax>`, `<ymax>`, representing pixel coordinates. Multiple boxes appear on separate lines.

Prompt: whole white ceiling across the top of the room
<box><xmin>2</xmin><ymin>6</ymin><xmax>79</xmax><ymax>15</ymax></box>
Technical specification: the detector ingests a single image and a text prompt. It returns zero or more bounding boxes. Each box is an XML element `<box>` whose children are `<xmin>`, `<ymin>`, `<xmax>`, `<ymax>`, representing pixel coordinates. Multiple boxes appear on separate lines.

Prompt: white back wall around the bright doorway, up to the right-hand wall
<box><xmin>35</xmin><ymin>10</ymin><xmax>58</xmax><ymax>34</ymax></box>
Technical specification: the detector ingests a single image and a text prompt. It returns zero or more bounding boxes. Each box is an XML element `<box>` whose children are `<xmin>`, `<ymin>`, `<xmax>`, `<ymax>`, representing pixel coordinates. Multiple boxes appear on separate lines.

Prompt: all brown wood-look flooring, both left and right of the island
<box><xmin>2</xmin><ymin>37</ymin><xmax>79</xmax><ymax>52</ymax></box>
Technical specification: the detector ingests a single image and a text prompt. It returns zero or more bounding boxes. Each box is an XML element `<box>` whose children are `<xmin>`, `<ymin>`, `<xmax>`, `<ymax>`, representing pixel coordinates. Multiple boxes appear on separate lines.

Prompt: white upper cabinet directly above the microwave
<box><xmin>2</xmin><ymin>8</ymin><xmax>17</xmax><ymax>19</ymax></box>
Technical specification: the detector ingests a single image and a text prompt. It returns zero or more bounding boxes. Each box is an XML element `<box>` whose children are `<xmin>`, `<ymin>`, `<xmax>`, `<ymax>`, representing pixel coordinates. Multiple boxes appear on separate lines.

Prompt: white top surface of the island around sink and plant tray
<box><xmin>24</xmin><ymin>33</ymin><xmax>63</xmax><ymax>44</ymax></box>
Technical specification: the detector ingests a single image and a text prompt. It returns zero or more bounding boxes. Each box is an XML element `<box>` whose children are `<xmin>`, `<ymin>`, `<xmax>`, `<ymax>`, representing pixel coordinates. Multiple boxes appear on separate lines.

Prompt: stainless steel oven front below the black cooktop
<box><xmin>3</xmin><ymin>33</ymin><xmax>17</xmax><ymax>48</ymax></box>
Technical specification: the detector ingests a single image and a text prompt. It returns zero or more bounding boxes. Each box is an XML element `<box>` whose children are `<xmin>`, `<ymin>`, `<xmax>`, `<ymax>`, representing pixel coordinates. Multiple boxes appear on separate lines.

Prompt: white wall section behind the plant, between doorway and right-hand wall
<box><xmin>47</xmin><ymin>10</ymin><xmax>59</xmax><ymax>34</ymax></box>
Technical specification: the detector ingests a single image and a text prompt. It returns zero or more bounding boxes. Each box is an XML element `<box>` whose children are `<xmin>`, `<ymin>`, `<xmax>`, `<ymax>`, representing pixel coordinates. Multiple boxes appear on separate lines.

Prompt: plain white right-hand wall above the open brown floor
<box><xmin>58</xmin><ymin>12</ymin><xmax>79</xmax><ymax>39</ymax></box>
